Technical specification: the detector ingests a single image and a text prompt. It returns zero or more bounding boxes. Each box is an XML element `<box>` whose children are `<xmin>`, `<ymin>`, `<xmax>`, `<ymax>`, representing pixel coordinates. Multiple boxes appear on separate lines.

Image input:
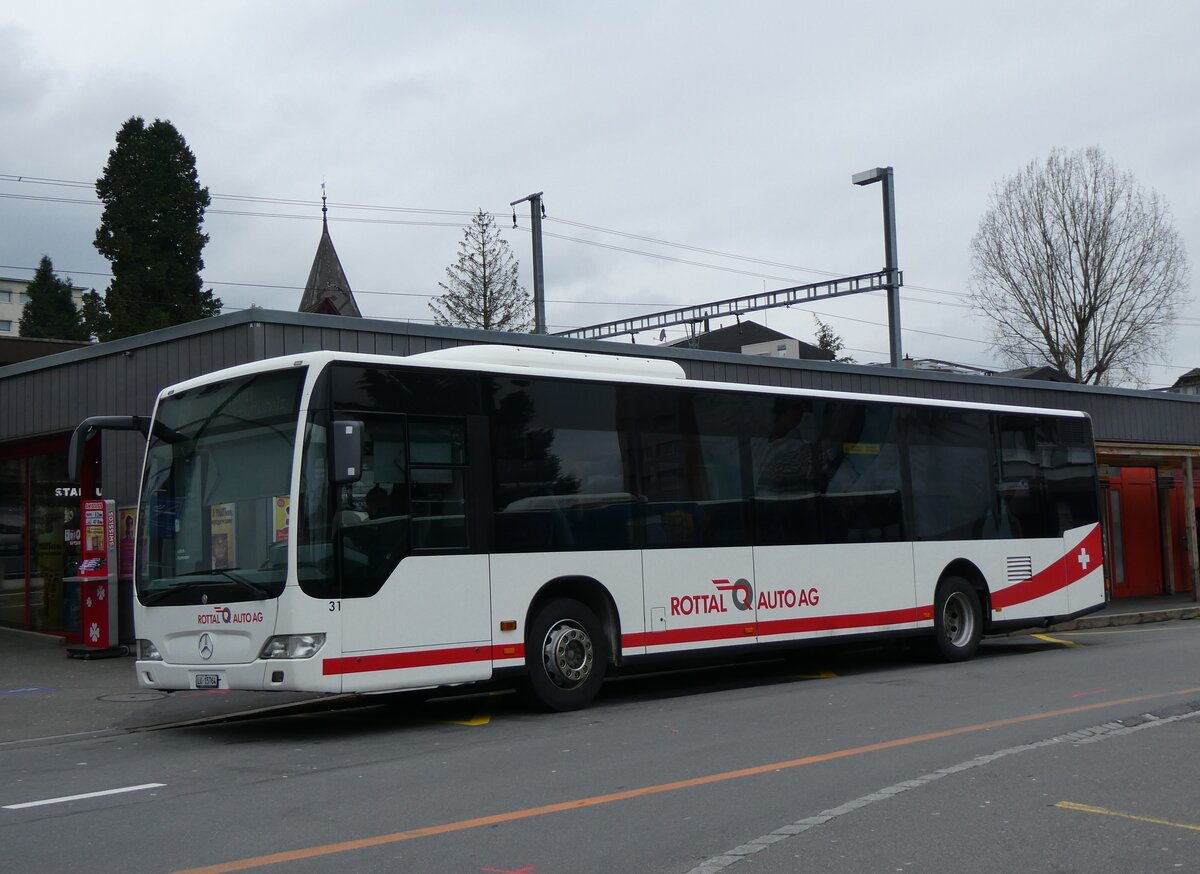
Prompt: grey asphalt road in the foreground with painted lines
<box><xmin>0</xmin><ymin>622</ymin><xmax>1200</xmax><ymax>874</ymax></box>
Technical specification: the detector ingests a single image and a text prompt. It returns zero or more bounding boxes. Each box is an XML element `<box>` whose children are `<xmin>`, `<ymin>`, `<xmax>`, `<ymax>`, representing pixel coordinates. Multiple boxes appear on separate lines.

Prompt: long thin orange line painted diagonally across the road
<box><xmin>176</xmin><ymin>687</ymin><xmax>1200</xmax><ymax>874</ymax></box>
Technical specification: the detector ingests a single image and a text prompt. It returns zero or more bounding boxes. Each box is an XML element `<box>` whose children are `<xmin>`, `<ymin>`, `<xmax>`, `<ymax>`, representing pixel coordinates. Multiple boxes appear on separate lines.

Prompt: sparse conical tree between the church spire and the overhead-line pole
<box><xmin>430</xmin><ymin>210</ymin><xmax>533</xmax><ymax>331</ymax></box>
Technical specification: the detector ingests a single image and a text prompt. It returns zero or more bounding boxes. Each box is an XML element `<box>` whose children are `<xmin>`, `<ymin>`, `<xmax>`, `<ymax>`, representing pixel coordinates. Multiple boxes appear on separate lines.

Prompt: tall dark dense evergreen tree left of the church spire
<box><xmin>85</xmin><ymin>116</ymin><xmax>221</xmax><ymax>340</ymax></box>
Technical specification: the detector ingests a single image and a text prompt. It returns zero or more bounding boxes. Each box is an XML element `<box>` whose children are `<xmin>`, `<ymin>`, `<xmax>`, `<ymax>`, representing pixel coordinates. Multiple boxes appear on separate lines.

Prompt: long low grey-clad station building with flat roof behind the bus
<box><xmin>0</xmin><ymin>307</ymin><xmax>1200</xmax><ymax>642</ymax></box>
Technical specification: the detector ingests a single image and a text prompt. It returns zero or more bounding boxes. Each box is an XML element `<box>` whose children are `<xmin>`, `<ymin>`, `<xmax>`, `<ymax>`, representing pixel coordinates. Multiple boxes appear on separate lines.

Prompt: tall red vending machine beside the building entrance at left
<box><xmin>67</xmin><ymin>501</ymin><xmax>124</xmax><ymax>658</ymax></box>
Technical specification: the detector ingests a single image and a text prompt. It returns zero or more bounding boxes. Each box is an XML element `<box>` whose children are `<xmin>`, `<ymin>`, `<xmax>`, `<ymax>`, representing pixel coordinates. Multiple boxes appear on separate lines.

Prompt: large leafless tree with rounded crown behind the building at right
<box><xmin>971</xmin><ymin>148</ymin><xmax>1189</xmax><ymax>385</ymax></box>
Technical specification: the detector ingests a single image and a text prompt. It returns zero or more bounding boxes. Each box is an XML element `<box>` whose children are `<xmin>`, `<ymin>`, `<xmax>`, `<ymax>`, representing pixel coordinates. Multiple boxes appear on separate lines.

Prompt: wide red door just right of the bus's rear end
<box><xmin>1109</xmin><ymin>467</ymin><xmax>1163</xmax><ymax>598</ymax></box>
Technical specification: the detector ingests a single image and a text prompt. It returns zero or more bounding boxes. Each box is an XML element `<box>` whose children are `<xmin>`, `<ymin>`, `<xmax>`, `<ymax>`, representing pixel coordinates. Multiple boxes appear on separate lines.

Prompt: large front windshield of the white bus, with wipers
<box><xmin>134</xmin><ymin>367</ymin><xmax>305</xmax><ymax>605</ymax></box>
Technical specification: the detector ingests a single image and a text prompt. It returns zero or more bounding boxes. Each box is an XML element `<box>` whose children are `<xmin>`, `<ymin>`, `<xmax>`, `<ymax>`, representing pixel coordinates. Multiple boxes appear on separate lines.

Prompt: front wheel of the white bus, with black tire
<box><xmin>526</xmin><ymin>598</ymin><xmax>608</xmax><ymax>712</ymax></box>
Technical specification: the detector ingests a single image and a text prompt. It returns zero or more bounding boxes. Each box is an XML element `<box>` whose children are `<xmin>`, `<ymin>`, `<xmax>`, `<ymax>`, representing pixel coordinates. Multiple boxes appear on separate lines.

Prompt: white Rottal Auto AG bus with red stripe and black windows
<box><xmin>73</xmin><ymin>346</ymin><xmax>1104</xmax><ymax>710</ymax></box>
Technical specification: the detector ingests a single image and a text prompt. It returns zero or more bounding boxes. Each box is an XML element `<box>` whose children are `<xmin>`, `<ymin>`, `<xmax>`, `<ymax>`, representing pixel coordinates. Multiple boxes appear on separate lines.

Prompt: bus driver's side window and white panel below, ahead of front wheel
<box><xmin>335</xmin><ymin>413</ymin><xmax>491</xmax><ymax>690</ymax></box>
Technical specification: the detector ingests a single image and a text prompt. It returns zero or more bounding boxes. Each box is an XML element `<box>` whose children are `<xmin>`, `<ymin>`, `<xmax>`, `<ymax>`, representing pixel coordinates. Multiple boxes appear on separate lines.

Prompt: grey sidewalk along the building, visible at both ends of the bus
<box><xmin>0</xmin><ymin>594</ymin><xmax>1200</xmax><ymax>750</ymax></box>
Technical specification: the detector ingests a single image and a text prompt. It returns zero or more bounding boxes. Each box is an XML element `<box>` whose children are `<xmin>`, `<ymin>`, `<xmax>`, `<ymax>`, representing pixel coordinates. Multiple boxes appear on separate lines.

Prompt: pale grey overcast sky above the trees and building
<box><xmin>0</xmin><ymin>0</ymin><xmax>1200</xmax><ymax>385</ymax></box>
